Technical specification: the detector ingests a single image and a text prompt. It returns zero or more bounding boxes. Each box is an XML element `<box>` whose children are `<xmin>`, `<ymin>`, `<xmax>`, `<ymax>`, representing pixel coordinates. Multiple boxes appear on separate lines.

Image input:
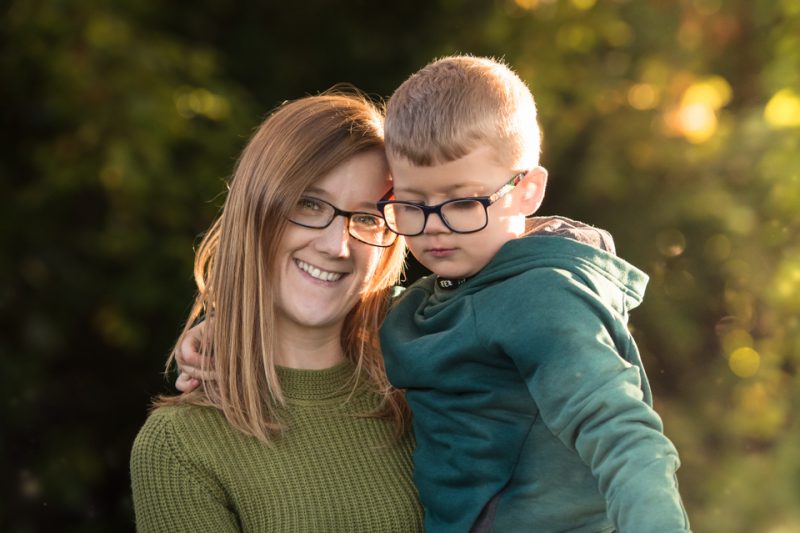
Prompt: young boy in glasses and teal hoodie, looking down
<box><xmin>379</xmin><ymin>56</ymin><xmax>689</xmax><ymax>533</ymax></box>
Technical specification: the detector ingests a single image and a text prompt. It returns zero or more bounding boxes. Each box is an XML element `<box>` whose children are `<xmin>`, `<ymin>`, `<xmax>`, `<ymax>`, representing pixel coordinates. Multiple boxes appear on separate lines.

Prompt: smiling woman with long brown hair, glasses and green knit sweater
<box><xmin>131</xmin><ymin>94</ymin><xmax>421</xmax><ymax>532</ymax></box>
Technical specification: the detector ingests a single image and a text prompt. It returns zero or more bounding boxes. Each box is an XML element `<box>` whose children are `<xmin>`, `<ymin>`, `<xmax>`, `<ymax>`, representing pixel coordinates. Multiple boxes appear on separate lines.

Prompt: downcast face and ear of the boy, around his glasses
<box><xmin>389</xmin><ymin>147</ymin><xmax>547</xmax><ymax>279</ymax></box>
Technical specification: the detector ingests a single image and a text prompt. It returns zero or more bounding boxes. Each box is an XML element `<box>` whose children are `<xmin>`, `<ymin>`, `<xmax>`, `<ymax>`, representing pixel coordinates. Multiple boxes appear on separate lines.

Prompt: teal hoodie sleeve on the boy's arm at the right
<box><xmin>484</xmin><ymin>270</ymin><xmax>689</xmax><ymax>533</ymax></box>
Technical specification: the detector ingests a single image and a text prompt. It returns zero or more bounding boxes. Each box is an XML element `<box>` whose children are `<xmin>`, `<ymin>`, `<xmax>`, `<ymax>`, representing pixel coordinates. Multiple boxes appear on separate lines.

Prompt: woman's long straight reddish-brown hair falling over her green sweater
<box><xmin>155</xmin><ymin>92</ymin><xmax>409</xmax><ymax>442</ymax></box>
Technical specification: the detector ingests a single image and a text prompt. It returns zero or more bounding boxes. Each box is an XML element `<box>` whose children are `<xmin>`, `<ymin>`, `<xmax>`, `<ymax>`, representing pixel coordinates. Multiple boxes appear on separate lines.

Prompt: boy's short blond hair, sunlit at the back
<box><xmin>385</xmin><ymin>56</ymin><xmax>541</xmax><ymax>168</ymax></box>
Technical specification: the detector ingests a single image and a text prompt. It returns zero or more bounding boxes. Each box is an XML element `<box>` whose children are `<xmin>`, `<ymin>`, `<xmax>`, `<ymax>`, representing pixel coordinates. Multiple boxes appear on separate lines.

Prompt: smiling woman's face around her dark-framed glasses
<box><xmin>276</xmin><ymin>150</ymin><xmax>391</xmax><ymax>335</ymax></box>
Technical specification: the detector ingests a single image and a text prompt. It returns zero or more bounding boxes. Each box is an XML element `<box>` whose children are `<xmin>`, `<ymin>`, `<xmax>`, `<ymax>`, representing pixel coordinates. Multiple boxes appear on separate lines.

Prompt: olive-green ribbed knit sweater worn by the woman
<box><xmin>131</xmin><ymin>363</ymin><xmax>422</xmax><ymax>533</ymax></box>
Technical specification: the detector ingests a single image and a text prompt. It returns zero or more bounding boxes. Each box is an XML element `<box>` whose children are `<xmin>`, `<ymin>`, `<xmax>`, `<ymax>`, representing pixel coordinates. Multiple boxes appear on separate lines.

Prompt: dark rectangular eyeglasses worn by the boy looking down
<box><xmin>378</xmin><ymin>170</ymin><xmax>528</xmax><ymax>237</ymax></box>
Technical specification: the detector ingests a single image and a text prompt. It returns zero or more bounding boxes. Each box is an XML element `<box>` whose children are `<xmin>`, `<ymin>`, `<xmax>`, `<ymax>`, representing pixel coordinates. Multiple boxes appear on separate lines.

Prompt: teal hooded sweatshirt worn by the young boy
<box><xmin>381</xmin><ymin>219</ymin><xmax>689</xmax><ymax>533</ymax></box>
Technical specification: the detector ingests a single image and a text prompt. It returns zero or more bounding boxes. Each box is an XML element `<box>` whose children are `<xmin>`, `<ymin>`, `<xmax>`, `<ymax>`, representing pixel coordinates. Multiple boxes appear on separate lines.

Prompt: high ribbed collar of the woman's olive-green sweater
<box><xmin>275</xmin><ymin>361</ymin><xmax>355</xmax><ymax>400</ymax></box>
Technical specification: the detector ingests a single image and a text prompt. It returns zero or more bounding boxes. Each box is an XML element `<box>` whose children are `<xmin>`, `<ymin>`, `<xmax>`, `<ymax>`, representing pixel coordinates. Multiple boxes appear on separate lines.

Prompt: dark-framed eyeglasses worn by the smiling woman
<box><xmin>287</xmin><ymin>191</ymin><xmax>397</xmax><ymax>248</ymax></box>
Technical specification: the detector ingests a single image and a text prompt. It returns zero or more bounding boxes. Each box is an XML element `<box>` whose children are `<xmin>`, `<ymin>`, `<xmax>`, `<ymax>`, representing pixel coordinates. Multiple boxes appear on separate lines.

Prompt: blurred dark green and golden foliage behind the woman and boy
<box><xmin>0</xmin><ymin>0</ymin><xmax>800</xmax><ymax>533</ymax></box>
